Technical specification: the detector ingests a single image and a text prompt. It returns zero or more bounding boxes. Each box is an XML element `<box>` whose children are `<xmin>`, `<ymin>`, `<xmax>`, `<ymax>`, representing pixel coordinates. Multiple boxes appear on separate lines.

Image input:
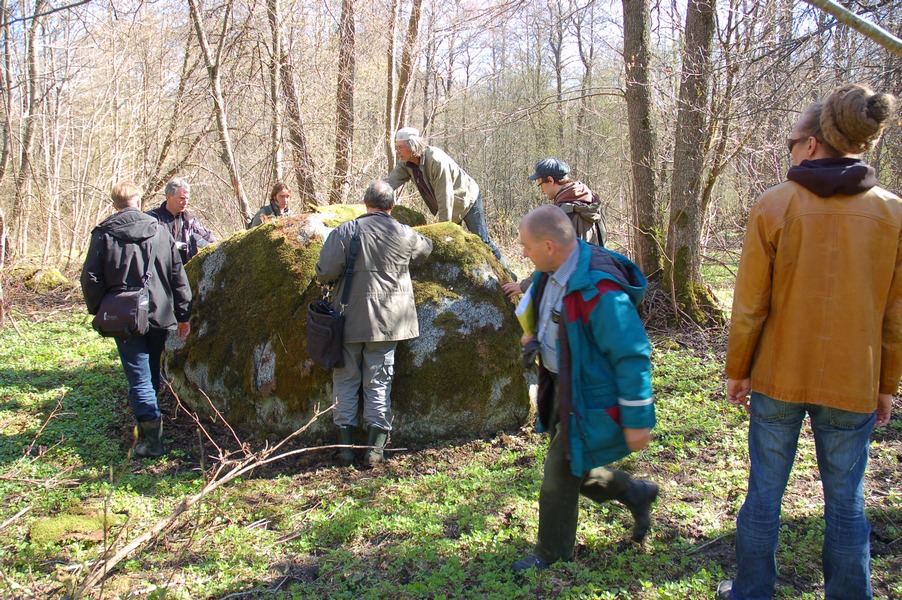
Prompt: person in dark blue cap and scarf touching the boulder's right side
<box><xmin>501</xmin><ymin>157</ymin><xmax>605</xmax><ymax>297</ymax></box>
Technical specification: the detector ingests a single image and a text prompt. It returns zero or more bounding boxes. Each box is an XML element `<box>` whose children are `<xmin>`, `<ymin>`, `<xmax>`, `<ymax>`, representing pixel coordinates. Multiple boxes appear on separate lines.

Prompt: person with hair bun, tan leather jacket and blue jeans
<box><xmin>717</xmin><ymin>84</ymin><xmax>902</xmax><ymax>600</ymax></box>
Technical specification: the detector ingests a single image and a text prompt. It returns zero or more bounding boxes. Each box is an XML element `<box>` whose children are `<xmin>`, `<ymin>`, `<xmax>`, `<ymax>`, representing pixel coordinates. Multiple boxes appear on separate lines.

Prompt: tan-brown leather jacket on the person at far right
<box><xmin>726</xmin><ymin>181</ymin><xmax>902</xmax><ymax>413</ymax></box>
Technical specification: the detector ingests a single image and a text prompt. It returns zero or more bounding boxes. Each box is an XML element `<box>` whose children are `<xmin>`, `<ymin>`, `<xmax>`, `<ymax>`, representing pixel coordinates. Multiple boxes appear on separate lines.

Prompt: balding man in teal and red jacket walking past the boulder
<box><xmin>514</xmin><ymin>205</ymin><xmax>658</xmax><ymax>571</ymax></box>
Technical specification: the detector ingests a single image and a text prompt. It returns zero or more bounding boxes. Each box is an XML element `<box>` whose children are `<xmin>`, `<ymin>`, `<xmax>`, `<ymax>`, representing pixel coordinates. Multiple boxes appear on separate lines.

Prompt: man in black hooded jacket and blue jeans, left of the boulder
<box><xmin>81</xmin><ymin>183</ymin><xmax>191</xmax><ymax>456</ymax></box>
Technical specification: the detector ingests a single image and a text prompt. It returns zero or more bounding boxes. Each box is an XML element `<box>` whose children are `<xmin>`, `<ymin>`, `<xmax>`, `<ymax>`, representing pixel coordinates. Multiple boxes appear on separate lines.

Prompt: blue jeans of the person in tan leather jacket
<box><xmin>730</xmin><ymin>392</ymin><xmax>875</xmax><ymax>600</ymax></box>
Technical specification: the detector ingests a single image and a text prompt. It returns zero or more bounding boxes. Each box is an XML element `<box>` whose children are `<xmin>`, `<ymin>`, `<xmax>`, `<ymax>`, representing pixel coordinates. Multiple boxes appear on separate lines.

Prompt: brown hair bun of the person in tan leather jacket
<box><xmin>820</xmin><ymin>83</ymin><xmax>896</xmax><ymax>154</ymax></box>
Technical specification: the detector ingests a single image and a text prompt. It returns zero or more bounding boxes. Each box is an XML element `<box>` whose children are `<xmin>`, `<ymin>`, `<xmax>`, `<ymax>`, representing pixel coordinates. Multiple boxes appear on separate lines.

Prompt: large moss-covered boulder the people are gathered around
<box><xmin>165</xmin><ymin>205</ymin><xmax>530</xmax><ymax>443</ymax></box>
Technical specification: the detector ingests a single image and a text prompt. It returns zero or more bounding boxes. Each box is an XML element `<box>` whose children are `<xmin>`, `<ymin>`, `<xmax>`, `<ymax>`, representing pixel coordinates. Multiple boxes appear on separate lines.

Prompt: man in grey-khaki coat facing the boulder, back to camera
<box><xmin>316</xmin><ymin>180</ymin><xmax>432</xmax><ymax>466</ymax></box>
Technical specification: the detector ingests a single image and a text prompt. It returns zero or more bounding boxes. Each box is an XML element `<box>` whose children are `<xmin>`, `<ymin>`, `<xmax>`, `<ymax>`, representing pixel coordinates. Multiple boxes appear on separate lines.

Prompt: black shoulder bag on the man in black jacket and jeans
<box><xmin>91</xmin><ymin>240</ymin><xmax>156</xmax><ymax>338</ymax></box>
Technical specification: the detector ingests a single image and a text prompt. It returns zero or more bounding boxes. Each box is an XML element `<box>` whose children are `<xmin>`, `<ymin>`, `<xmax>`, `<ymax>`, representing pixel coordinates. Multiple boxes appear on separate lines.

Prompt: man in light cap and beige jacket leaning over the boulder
<box><xmin>386</xmin><ymin>127</ymin><xmax>507</xmax><ymax>268</ymax></box>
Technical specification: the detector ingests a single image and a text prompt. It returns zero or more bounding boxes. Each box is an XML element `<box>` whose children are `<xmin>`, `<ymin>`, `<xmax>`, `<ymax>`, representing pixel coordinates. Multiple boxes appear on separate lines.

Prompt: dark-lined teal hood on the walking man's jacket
<box><xmin>568</xmin><ymin>240</ymin><xmax>648</xmax><ymax>306</ymax></box>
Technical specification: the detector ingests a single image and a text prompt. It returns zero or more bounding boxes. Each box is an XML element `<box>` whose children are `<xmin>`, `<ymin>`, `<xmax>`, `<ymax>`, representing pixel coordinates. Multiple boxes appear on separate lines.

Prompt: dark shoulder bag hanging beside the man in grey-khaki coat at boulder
<box><xmin>306</xmin><ymin>220</ymin><xmax>360</xmax><ymax>369</ymax></box>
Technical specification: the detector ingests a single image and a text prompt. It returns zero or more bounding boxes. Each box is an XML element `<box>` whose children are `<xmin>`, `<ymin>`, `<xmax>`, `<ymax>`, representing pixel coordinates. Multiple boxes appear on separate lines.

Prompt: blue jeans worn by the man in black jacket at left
<box><xmin>116</xmin><ymin>327</ymin><xmax>169</xmax><ymax>422</ymax></box>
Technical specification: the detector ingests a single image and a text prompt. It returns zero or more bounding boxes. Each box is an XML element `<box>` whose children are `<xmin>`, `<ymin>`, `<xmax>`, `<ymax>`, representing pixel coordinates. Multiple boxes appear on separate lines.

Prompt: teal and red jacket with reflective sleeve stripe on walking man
<box><xmin>527</xmin><ymin>240</ymin><xmax>655</xmax><ymax>477</ymax></box>
